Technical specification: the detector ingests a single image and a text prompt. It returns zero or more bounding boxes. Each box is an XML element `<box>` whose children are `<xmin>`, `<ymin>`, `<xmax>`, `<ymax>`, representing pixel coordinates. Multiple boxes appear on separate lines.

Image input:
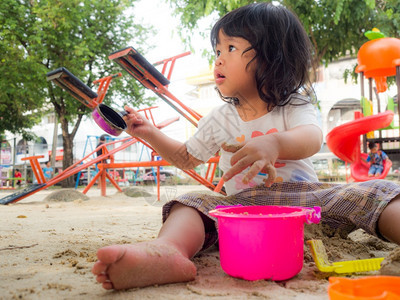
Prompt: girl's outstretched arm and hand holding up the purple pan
<box><xmin>125</xmin><ymin>106</ymin><xmax>203</xmax><ymax>170</ymax></box>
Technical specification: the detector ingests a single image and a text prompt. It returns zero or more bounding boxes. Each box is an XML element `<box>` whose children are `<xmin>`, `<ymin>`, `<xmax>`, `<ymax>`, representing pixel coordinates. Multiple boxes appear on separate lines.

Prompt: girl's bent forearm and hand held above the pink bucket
<box><xmin>222</xmin><ymin>125</ymin><xmax>322</xmax><ymax>186</ymax></box>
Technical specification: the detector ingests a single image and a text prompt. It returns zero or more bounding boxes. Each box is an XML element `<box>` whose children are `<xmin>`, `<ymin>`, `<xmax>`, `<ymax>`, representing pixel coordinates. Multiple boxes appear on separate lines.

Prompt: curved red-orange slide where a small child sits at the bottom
<box><xmin>326</xmin><ymin>111</ymin><xmax>394</xmax><ymax>181</ymax></box>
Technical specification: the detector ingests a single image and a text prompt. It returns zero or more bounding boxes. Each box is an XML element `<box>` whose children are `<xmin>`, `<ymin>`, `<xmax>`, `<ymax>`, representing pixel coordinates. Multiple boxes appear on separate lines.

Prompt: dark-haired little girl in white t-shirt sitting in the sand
<box><xmin>92</xmin><ymin>3</ymin><xmax>400</xmax><ymax>289</ymax></box>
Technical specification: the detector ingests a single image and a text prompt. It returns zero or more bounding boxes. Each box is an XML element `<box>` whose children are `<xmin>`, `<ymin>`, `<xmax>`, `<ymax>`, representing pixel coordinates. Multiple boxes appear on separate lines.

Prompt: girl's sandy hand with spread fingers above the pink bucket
<box><xmin>222</xmin><ymin>134</ymin><xmax>279</xmax><ymax>187</ymax></box>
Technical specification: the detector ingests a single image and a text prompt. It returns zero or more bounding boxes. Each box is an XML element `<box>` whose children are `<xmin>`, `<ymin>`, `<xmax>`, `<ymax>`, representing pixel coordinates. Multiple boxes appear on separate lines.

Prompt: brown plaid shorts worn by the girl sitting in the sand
<box><xmin>163</xmin><ymin>180</ymin><xmax>400</xmax><ymax>250</ymax></box>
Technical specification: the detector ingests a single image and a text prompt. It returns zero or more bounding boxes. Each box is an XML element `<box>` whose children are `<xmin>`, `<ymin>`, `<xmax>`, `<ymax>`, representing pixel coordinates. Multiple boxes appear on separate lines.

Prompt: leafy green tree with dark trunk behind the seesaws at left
<box><xmin>0</xmin><ymin>0</ymin><xmax>155</xmax><ymax>186</ymax></box>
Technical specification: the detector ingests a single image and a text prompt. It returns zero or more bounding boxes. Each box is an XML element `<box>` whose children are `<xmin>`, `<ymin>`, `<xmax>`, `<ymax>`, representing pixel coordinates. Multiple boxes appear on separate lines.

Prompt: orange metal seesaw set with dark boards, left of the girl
<box><xmin>0</xmin><ymin>47</ymin><xmax>224</xmax><ymax>204</ymax></box>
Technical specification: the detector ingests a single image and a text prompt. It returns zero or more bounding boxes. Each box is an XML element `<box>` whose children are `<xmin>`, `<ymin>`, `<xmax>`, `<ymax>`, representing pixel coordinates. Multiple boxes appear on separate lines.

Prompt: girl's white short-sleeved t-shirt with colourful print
<box><xmin>186</xmin><ymin>95</ymin><xmax>319</xmax><ymax>195</ymax></box>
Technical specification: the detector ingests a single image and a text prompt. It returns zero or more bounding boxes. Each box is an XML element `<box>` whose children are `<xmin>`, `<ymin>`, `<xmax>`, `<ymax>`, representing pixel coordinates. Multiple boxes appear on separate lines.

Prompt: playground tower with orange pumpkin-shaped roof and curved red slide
<box><xmin>326</xmin><ymin>34</ymin><xmax>400</xmax><ymax>181</ymax></box>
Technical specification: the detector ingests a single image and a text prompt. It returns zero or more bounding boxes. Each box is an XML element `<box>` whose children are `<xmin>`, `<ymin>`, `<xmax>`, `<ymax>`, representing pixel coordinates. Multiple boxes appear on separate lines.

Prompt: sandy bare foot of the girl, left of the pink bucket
<box><xmin>92</xmin><ymin>240</ymin><xmax>196</xmax><ymax>290</ymax></box>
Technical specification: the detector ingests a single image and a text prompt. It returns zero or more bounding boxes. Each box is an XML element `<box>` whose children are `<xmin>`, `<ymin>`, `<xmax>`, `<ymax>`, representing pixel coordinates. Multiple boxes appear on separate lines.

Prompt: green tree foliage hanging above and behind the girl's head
<box><xmin>169</xmin><ymin>0</ymin><xmax>400</xmax><ymax>71</ymax></box>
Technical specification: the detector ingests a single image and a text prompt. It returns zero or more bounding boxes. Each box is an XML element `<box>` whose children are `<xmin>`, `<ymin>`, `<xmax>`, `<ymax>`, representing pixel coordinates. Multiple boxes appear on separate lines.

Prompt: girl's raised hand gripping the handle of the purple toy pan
<box><xmin>124</xmin><ymin>105</ymin><xmax>155</xmax><ymax>139</ymax></box>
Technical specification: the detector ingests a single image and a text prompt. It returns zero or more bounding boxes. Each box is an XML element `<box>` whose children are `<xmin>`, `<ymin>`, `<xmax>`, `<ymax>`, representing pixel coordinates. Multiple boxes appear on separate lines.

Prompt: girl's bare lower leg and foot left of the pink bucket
<box><xmin>92</xmin><ymin>203</ymin><xmax>205</xmax><ymax>289</ymax></box>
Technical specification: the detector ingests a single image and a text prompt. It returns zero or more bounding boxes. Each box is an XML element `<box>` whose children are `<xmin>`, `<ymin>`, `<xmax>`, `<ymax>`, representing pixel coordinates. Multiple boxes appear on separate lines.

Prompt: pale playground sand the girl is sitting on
<box><xmin>0</xmin><ymin>186</ymin><xmax>400</xmax><ymax>300</ymax></box>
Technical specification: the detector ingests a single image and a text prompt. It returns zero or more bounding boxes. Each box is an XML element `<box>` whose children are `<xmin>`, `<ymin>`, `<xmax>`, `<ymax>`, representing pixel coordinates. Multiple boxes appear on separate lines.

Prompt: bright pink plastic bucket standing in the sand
<box><xmin>209</xmin><ymin>206</ymin><xmax>321</xmax><ymax>281</ymax></box>
